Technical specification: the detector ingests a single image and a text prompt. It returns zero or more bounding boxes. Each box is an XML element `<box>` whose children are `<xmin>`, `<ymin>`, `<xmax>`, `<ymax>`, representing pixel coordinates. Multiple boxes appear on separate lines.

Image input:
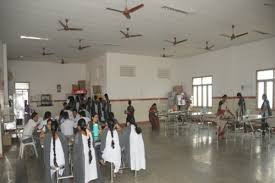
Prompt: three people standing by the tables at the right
<box><xmin>216</xmin><ymin>93</ymin><xmax>272</xmax><ymax>139</ymax></box>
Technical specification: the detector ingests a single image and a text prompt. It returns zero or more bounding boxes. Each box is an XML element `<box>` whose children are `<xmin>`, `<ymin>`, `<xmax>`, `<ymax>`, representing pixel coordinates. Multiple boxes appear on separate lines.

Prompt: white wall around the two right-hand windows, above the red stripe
<box><xmin>175</xmin><ymin>38</ymin><xmax>275</xmax><ymax>96</ymax></box>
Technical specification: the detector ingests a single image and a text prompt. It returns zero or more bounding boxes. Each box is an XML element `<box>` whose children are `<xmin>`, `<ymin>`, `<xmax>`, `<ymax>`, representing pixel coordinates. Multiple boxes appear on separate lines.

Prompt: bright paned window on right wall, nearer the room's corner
<box><xmin>193</xmin><ymin>76</ymin><xmax>213</xmax><ymax>107</ymax></box>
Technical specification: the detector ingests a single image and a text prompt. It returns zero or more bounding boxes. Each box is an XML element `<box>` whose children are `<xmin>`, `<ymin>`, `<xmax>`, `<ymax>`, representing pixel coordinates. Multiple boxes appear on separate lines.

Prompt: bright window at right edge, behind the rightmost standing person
<box><xmin>257</xmin><ymin>69</ymin><xmax>275</xmax><ymax>109</ymax></box>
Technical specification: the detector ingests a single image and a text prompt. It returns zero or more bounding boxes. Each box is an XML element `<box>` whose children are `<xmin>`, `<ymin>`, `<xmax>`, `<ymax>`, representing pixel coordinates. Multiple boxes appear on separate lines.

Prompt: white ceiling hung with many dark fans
<box><xmin>0</xmin><ymin>0</ymin><xmax>275</xmax><ymax>62</ymax></box>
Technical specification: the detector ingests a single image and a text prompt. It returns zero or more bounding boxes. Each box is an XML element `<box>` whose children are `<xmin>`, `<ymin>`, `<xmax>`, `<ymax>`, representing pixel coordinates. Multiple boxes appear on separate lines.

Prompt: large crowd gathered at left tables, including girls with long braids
<box><xmin>23</xmin><ymin>96</ymin><xmax>146</xmax><ymax>183</ymax></box>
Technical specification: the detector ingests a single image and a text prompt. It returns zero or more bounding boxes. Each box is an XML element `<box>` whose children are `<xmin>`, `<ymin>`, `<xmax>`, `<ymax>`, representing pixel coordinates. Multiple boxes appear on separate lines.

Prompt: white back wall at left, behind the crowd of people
<box><xmin>8</xmin><ymin>61</ymin><xmax>86</xmax><ymax>115</ymax></box>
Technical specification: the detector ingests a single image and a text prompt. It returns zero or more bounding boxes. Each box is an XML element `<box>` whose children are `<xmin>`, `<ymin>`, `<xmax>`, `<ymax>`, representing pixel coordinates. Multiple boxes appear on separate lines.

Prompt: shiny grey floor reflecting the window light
<box><xmin>0</xmin><ymin>126</ymin><xmax>275</xmax><ymax>183</ymax></box>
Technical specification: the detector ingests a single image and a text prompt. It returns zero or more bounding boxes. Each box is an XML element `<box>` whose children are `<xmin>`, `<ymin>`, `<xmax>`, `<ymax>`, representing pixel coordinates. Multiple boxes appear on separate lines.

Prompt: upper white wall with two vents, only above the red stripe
<box><xmin>107</xmin><ymin>53</ymin><xmax>174</xmax><ymax>99</ymax></box>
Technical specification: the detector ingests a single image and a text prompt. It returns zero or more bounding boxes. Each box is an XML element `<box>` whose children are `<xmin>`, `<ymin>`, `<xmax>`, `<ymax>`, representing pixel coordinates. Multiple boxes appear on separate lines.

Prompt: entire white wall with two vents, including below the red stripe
<box><xmin>107</xmin><ymin>53</ymin><xmax>177</xmax><ymax>122</ymax></box>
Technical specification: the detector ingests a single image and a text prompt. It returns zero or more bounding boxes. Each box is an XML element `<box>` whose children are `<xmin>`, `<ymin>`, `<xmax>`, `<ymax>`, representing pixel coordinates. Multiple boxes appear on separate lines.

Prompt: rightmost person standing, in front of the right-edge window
<box><xmin>261</xmin><ymin>94</ymin><xmax>272</xmax><ymax>136</ymax></box>
